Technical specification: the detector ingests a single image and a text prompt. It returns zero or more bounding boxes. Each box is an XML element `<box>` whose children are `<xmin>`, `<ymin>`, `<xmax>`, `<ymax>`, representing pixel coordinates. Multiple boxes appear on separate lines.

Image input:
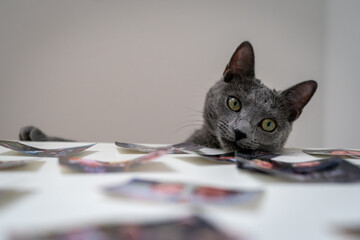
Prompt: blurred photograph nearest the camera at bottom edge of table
<box><xmin>11</xmin><ymin>217</ymin><xmax>239</xmax><ymax>240</ymax></box>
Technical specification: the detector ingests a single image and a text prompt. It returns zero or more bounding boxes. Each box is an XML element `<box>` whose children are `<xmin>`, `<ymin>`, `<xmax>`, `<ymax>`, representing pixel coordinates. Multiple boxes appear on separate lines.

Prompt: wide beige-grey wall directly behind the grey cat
<box><xmin>0</xmin><ymin>0</ymin><xmax>326</xmax><ymax>147</ymax></box>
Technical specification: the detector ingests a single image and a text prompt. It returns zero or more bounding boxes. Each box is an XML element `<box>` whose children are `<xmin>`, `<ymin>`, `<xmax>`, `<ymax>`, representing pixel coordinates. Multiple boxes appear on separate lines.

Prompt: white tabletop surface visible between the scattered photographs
<box><xmin>0</xmin><ymin>142</ymin><xmax>360</xmax><ymax>240</ymax></box>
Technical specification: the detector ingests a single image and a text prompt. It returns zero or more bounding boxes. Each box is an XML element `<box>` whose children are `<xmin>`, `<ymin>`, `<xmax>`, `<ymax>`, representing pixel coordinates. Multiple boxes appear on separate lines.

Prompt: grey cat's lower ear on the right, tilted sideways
<box><xmin>281</xmin><ymin>80</ymin><xmax>317</xmax><ymax>122</ymax></box>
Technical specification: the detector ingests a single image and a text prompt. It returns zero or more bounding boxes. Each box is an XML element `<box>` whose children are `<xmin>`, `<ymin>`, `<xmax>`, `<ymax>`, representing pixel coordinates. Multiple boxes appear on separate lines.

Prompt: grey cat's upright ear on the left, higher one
<box><xmin>223</xmin><ymin>42</ymin><xmax>255</xmax><ymax>82</ymax></box>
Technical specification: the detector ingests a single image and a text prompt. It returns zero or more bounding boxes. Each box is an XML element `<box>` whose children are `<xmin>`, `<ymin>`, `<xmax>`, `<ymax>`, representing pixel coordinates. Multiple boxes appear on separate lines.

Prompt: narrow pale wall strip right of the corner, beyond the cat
<box><xmin>324</xmin><ymin>0</ymin><xmax>360</xmax><ymax>148</ymax></box>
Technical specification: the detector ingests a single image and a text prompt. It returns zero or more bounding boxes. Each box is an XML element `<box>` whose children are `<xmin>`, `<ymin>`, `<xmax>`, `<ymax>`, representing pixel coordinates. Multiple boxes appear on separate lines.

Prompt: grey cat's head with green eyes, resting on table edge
<box><xmin>204</xmin><ymin>42</ymin><xmax>317</xmax><ymax>151</ymax></box>
